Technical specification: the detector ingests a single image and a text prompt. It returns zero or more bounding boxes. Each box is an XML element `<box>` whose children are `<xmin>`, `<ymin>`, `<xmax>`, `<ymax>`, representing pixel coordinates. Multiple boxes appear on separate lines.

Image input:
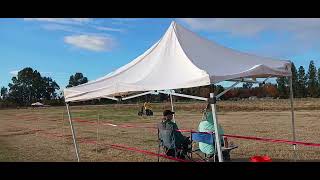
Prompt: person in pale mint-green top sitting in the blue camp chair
<box><xmin>198</xmin><ymin>104</ymin><xmax>228</xmax><ymax>160</ymax></box>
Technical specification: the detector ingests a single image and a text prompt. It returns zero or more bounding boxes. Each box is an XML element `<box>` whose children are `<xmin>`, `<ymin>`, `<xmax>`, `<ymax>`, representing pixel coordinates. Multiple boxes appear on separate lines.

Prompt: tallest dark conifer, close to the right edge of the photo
<box><xmin>307</xmin><ymin>61</ymin><xmax>318</xmax><ymax>97</ymax></box>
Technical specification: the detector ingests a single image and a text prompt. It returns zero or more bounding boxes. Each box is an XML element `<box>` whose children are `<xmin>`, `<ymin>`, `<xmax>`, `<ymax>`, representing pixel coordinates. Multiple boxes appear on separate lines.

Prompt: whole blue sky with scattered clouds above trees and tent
<box><xmin>0</xmin><ymin>18</ymin><xmax>320</xmax><ymax>92</ymax></box>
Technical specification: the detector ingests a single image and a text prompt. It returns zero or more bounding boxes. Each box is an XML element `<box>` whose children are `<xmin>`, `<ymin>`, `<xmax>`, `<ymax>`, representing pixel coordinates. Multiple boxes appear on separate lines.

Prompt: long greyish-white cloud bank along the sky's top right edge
<box><xmin>178</xmin><ymin>18</ymin><xmax>320</xmax><ymax>37</ymax></box>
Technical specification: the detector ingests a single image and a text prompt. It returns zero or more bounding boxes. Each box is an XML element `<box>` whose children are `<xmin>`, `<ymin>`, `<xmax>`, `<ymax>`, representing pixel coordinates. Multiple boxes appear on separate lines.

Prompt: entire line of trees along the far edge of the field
<box><xmin>0</xmin><ymin>61</ymin><xmax>320</xmax><ymax>108</ymax></box>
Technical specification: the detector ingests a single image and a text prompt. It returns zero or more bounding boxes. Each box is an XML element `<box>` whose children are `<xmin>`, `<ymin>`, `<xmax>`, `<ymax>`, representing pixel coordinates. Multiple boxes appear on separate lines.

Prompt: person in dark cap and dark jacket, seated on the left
<box><xmin>158</xmin><ymin>110</ymin><xmax>191</xmax><ymax>159</ymax></box>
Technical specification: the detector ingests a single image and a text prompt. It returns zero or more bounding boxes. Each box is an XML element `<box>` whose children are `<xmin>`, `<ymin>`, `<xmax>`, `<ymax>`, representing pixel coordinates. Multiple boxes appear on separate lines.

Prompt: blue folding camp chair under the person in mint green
<box><xmin>191</xmin><ymin>132</ymin><xmax>238</xmax><ymax>162</ymax></box>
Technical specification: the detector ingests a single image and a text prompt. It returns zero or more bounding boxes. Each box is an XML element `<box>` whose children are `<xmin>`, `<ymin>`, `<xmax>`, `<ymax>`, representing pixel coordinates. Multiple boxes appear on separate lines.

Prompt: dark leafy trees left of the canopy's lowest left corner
<box><xmin>0</xmin><ymin>67</ymin><xmax>88</xmax><ymax>108</ymax></box>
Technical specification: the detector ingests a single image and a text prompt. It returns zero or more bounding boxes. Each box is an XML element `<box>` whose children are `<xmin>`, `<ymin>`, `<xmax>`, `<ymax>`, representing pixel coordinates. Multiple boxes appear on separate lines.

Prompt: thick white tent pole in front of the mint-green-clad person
<box><xmin>210</xmin><ymin>92</ymin><xmax>223</xmax><ymax>162</ymax></box>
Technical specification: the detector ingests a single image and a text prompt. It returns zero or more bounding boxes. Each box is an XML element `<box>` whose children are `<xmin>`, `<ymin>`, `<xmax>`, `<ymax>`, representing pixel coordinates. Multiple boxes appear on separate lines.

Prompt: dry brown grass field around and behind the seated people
<box><xmin>0</xmin><ymin>99</ymin><xmax>320</xmax><ymax>162</ymax></box>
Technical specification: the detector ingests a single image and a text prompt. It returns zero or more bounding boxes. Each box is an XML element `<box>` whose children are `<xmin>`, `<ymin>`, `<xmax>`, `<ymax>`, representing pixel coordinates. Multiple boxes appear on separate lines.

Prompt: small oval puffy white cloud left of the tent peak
<box><xmin>64</xmin><ymin>35</ymin><xmax>115</xmax><ymax>51</ymax></box>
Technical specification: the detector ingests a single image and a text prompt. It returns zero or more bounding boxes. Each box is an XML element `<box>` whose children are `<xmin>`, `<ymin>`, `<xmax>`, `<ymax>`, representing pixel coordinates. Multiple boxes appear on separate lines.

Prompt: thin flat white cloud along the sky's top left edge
<box><xmin>24</xmin><ymin>18</ymin><xmax>91</xmax><ymax>25</ymax></box>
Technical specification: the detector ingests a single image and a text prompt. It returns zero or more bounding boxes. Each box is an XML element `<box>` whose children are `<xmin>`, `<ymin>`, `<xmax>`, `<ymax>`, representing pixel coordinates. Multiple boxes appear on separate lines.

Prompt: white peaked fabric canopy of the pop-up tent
<box><xmin>64</xmin><ymin>22</ymin><xmax>291</xmax><ymax>102</ymax></box>
